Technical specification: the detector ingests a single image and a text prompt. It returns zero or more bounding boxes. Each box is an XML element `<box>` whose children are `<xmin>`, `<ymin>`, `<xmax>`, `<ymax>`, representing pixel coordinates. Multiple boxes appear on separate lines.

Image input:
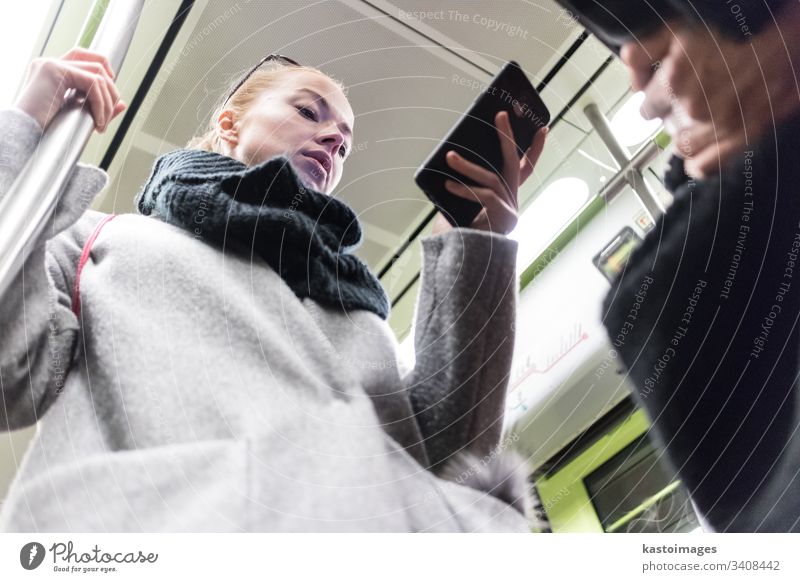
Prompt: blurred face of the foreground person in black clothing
<box><xmin>620</xmin><ymin>3</ymin><xmax>800</xmax><ymax>178</ymax></box>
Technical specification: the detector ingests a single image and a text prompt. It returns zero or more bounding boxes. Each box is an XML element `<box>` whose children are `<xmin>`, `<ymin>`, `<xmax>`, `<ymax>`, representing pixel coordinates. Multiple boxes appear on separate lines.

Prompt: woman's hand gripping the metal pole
<box><xmin>14</xmin><ymin>48</ymin><xmax>126</xmax><ymax>133</ymax></box>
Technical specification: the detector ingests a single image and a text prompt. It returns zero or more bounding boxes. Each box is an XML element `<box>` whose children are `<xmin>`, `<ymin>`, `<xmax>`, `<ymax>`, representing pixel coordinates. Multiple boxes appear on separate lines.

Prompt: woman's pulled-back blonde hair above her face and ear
<box><xmin>186</xmin><ymin>61</ymin><xmax>345</xmax><ymax>154</ymax></box>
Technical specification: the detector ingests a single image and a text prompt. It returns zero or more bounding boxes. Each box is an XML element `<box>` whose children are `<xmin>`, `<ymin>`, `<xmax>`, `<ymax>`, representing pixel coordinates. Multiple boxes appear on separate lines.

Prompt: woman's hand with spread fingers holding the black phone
<box><xmin>433</xmin><ymin>111</ymin><xmax>548</xmax><ymax>234</ymax></box>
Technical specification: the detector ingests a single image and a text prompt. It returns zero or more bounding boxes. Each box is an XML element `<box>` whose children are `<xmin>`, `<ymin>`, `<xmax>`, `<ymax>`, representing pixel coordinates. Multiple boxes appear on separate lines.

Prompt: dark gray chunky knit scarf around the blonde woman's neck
<box><xmin>136</xmin><ymin>149</ymin><xmax>389</xmax><ymax>319</ymax></box>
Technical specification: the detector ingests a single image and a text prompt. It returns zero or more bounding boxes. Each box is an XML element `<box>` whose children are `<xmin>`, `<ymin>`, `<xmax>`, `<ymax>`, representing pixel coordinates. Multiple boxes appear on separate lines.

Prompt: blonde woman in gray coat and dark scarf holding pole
<box><xmin>0</xmin><ymin>49</ymin><xmax>544</xmax><ymax>532</ymax></box>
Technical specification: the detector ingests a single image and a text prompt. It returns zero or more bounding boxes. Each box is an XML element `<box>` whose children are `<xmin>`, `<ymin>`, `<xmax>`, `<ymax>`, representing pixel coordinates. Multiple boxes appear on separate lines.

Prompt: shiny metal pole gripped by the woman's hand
<box><xmin>0</xmin><ymin>0</ymin><xmax>144</xmax><ymax>297</ymax></box>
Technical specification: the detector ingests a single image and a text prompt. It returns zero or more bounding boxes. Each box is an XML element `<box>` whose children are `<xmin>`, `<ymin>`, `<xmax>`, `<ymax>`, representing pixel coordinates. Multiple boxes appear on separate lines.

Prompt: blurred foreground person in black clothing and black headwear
<box><xmin>592</xmin><ymin>0</ymin><xmax>800</xmax><ymax>532</ymax></box>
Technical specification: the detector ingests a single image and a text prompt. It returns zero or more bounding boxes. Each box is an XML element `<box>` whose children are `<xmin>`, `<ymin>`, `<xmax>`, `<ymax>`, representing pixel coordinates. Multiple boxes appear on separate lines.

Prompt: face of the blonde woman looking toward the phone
<box><xmin>219</xmin><ymin>69</ymin><xmax>354</xmax><ymax>194</ymax></box>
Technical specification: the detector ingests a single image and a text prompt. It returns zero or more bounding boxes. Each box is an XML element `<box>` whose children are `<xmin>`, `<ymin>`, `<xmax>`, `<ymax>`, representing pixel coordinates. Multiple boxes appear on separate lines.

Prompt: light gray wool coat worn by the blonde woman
<box><xmin>0</xmin><ymin>110</ymin><xmax>528</xmax><ymax>532</ymax></box>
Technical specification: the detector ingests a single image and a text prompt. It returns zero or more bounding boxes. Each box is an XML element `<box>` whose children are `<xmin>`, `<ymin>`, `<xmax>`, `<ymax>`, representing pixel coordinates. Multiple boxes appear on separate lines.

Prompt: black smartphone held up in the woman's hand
<box><xmin>414</xmin><ymin>61</ymin><xmax>550</xmax><ymax>226</ymax></box>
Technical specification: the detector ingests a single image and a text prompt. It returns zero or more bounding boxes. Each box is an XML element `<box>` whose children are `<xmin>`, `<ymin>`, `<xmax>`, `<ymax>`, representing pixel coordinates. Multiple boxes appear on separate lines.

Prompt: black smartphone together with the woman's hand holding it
<box><xmin>414</xmin><ymin>61</ymin><xmax>550</xmax><ymax>232</ymax></box>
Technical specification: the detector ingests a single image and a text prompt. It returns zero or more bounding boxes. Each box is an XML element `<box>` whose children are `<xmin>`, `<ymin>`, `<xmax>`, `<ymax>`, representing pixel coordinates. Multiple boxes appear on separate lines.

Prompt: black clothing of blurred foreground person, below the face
<box><xmin>604</xmin><ymin>112</ymin><xmax>800</xmax><ymax>531</ymax></box>
